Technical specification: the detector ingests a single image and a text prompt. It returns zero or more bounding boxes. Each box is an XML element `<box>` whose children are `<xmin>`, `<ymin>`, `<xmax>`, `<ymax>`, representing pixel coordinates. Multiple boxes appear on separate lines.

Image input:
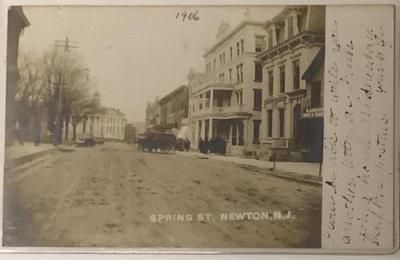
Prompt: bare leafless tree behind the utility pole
<box><xmin>43</xmin><ymin>49</ymin><xmax>94</xmax><ymax>143</ymax></box>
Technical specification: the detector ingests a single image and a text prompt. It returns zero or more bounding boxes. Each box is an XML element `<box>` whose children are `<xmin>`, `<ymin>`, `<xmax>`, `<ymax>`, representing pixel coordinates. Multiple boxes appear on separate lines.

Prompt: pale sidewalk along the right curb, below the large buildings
<box><xmin>176</xmin><ymin>151</ymin><xmax>322</xmax><ymax>183</ymax></box>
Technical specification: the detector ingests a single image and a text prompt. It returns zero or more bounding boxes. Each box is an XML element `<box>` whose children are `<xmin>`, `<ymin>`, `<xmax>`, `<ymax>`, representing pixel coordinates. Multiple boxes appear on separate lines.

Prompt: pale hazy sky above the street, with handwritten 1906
<box><xmin>19</xmin><ymin>6</ymin><xmax>283</xmax><ymax>122</ymax></box>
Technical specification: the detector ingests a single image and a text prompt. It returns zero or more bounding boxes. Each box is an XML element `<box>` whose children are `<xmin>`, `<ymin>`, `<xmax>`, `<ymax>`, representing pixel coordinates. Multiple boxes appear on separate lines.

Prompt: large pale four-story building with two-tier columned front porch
<box><xmin>187</xmin><ymin>16</ymin><xmax>266</xmax><ymax>154</ymax></box>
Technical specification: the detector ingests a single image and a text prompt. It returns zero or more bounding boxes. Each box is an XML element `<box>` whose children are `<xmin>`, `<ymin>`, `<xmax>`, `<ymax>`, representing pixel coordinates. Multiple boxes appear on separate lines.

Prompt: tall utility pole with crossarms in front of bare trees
<box><xmin>54</xmin><ymin>37</ymin><xmax>78</xmax><ymax>145</ymax></box>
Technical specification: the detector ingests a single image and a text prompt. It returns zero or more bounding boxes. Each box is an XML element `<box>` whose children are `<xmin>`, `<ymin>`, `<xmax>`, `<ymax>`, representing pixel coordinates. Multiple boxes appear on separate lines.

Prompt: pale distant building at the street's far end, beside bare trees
<box><xmin>86</xmin><ymin>107</ymin><xmax>127</xmax><ymax>140</ymax></box>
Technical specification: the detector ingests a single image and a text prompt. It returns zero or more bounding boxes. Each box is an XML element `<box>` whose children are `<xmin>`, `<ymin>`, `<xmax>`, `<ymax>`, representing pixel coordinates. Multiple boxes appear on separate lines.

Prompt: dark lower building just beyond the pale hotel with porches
<box><xmin>158</xmin><ymin>85</ymin><xmax>189</xmax><ymax>129</ymax></box>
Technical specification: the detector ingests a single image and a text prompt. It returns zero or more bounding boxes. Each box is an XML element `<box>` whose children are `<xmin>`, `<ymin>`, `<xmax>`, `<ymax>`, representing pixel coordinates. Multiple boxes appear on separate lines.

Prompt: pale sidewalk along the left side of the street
<box><xmin>4</xmin><ymin>142</ymin><xmax>57</xmax><ymax>169</ymax></box>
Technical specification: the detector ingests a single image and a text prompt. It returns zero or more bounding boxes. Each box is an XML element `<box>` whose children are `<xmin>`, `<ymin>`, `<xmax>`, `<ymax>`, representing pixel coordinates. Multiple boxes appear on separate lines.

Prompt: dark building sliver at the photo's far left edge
<box><xmin>5</xmin><ymin>6</ymin><xmax>30</xmax><ymax>145</ymax></box>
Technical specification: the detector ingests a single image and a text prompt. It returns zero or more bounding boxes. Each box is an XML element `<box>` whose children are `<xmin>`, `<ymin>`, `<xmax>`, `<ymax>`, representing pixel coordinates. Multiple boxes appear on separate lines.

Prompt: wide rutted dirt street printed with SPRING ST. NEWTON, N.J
<box><xmin>3</xmin><ymin>143</ymin><xmax>321</xmax><ymax>248</ymax></box>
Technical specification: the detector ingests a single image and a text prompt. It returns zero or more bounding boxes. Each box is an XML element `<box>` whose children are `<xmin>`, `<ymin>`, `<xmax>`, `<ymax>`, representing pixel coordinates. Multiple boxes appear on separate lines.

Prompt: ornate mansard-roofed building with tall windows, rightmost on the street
<box><xmin>258</xmin><ymin>6</ymin><xmax>325</xmax><ymax>160</ymax></box>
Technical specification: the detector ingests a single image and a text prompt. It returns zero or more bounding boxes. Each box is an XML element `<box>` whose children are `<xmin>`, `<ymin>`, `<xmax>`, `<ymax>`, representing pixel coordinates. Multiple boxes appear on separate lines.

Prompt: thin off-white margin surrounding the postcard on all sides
<box><xmin>0</xmin><ymin>0</ymin><xmax>400</xmax><ymax>259</ymax></box>
